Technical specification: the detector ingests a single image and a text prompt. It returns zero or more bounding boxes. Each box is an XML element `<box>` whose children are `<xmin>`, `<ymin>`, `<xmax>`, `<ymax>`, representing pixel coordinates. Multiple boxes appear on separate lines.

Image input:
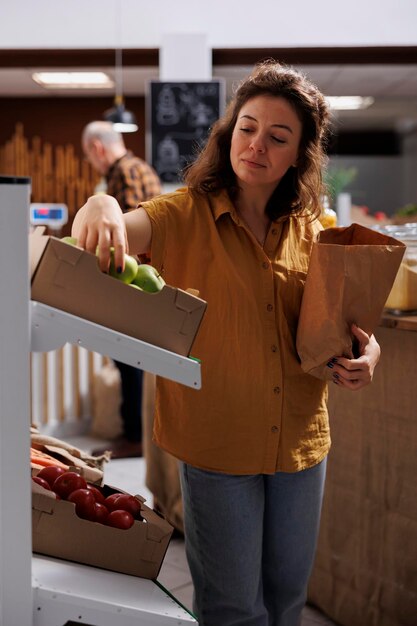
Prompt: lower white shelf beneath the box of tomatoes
<box><xmin>32</xmin><ymin>555</ymin><xmax>197</xmax><ymax>626</ymax></box>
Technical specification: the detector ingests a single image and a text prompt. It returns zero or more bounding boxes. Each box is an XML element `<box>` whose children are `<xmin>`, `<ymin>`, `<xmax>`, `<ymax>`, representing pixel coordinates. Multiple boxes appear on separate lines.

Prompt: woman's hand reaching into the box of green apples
<box><xmin>71</xmin><ymin>194</ymin><xmax>128</xmax><ymax>272</ymax></box>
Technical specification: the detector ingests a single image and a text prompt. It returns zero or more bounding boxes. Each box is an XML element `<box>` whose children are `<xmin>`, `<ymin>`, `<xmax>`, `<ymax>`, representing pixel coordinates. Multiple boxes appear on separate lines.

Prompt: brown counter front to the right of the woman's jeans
<box><xmin>309</xmin><ymin>314</ymin><xmax>417</xmax><ymax>626</ymax></box>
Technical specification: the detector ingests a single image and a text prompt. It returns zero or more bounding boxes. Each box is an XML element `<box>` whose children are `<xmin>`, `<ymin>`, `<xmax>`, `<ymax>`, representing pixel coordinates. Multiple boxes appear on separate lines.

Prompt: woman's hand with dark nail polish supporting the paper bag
<box><xmin>327</xmin><ymin>324</ymin><xmax>381</xmax><ymax>391</ymax></box>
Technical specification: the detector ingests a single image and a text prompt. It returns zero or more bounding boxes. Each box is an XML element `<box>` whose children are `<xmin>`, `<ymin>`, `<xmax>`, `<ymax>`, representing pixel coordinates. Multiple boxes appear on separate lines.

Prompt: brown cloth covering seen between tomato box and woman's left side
<box><xmin>142</xmin><ymin>372</ymin><xmax>184</xmax><ymax>533</ymax></box>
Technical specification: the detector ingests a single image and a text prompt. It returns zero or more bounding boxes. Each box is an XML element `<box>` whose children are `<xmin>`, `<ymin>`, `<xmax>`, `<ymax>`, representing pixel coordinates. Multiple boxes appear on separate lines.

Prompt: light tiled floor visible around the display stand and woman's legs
<box><xmin>66</xmin><ymin>437</ymin><xmax>336</xmax><ymax>626</ymax></box>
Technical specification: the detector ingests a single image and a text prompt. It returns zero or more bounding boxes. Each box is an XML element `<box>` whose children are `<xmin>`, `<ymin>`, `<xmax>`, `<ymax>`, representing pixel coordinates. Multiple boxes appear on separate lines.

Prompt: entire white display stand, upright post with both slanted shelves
<box><xmin>0</xmin><ymin>176</ymin><xmax>201</xmax><ymax>626</ymax></box>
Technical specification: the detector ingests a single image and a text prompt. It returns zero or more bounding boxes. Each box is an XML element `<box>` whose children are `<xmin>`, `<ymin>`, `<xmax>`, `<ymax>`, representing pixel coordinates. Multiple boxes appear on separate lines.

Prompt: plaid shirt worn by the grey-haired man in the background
<box><xmin>106</xmin><ymin>151</ymin><xmax>162</xmax><ymax>213</ymax></box>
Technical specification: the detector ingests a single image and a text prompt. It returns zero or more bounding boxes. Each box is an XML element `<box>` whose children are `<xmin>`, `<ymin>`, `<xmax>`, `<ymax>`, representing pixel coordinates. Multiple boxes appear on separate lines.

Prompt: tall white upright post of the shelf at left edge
<box><xmin>0</xmin><ymin>176</ymin><xmax>32</xmax><ymax>626</ymax></box>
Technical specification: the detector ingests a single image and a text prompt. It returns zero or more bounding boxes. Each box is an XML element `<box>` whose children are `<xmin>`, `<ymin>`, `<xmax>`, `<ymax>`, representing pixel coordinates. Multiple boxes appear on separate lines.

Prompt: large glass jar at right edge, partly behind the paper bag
<box><xmin>384</xmin><ymin>223</ymin><xmax>417</xmax><ymax>315</ymax></box>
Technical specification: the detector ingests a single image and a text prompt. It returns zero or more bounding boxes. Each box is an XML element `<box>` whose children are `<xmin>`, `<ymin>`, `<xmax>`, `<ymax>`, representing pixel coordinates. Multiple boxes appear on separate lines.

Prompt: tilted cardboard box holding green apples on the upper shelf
<box><xmin>30</xmin><ymin>229</ymin><xmax>207</xmax><ymax>356</ymax></box>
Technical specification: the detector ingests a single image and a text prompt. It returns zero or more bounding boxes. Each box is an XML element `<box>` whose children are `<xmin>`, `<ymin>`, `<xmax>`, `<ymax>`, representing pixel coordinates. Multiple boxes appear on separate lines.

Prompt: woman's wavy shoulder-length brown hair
<box><xmin>184</xmin><ymin>60</ymin><xmax>329</xmax><ymax>220</ymax></box>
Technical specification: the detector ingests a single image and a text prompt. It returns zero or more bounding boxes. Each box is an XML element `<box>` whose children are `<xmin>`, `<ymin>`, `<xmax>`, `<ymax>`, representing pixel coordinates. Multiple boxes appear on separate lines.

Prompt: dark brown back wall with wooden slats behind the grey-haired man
<box><xmin>0</xmin><ymin>98</ymin><xmax>145</xmax><ymax>236</ymax></box>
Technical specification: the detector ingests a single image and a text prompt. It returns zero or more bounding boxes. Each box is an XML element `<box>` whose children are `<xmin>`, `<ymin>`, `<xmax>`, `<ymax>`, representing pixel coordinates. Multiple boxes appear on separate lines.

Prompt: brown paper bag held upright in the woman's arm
<box><xmin>297</xmin><ymin>224</ymin><xmax>405</xmax><ymax>379</ymax></box>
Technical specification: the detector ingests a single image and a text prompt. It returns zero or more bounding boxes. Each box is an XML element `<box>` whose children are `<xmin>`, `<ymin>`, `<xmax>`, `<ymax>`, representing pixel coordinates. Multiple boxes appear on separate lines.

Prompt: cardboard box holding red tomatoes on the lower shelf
<box><xmin>32</xmin><ymin>483</ymin><xmax>173</xmax><ymax>579</ymax></box>
